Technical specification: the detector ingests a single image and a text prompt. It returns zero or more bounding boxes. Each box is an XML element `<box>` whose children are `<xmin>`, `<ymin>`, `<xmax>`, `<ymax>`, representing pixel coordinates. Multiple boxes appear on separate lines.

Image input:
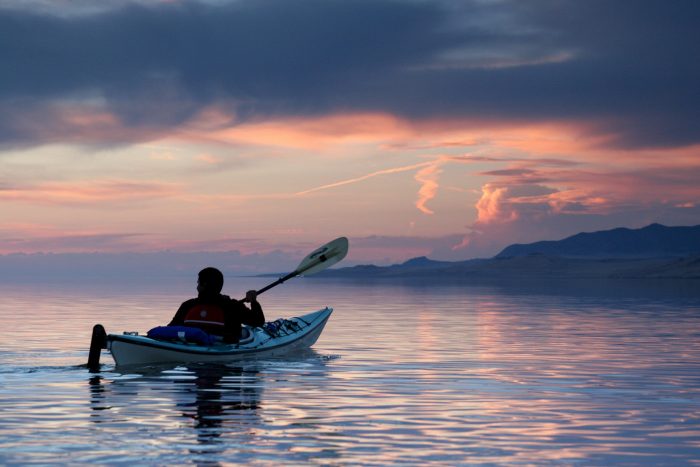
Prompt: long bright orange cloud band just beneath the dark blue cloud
<box><xmin>174</xmin><ymin>108</ymin><xmax>600</xmax><ymax>156</ymax></box>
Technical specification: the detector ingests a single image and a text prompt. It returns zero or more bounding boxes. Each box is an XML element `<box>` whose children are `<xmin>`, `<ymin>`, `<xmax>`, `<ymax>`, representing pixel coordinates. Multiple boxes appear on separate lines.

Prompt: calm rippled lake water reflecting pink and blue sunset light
<box><xmin>0</xmin><ymin>279</ymin><xmax>700</xmax><ymax>465</ymax></box>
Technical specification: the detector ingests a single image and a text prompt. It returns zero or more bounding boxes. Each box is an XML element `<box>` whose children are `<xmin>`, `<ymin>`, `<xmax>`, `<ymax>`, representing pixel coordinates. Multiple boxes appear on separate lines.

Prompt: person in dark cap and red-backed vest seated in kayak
<box><xmin>168</xmin><ymin>267</ymin><xmax>265</xmax><ymax>343</ymax></box>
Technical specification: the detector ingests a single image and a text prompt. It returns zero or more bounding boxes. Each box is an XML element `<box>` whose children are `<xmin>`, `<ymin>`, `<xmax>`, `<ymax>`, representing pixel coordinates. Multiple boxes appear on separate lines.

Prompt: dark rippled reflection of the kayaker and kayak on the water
<box><xmin>88</xmin><ymin>364</ymin><xmax>263</xmax><ymax>458</ymax></box>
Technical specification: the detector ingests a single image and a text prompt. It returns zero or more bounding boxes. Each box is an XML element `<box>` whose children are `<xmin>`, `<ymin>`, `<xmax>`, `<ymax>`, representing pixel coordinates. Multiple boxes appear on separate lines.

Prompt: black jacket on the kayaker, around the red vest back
<box><xmin>168</xmin><ymin>294</ymin><xmax>265</xmax><ymax>342</ymax></box>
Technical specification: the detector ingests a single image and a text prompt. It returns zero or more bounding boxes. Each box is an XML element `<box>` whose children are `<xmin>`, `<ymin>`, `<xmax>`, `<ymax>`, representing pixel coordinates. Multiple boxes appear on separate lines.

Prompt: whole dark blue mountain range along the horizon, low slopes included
<box><xmin>321</xmin><ymin>224</ymin><xmax>700</xmax><ymax>280</ymax></box>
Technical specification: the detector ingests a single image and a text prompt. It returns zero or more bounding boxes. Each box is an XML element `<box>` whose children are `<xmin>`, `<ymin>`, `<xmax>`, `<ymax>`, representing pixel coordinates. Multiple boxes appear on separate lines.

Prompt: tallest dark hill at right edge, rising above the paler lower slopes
<box><xmin>496</xmin><ymin>224</ymin><xmax>700</xmax><ymax>258</ymax></box>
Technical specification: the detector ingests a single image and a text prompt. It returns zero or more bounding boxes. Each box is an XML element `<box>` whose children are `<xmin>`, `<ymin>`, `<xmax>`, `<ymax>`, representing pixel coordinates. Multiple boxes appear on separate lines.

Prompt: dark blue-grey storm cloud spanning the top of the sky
<box><xmin>0</xmin><ymin>0</ymin><xmax>700</xmax><ymax>146</ymax></box>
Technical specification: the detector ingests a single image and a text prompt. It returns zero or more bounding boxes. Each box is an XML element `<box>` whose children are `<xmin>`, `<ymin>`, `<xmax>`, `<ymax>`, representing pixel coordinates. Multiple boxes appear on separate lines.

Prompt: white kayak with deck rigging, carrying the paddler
<box><xmin>106</xmin><ymin>307</ymin><xmax>333</xmax><ymax>366</ymax></box>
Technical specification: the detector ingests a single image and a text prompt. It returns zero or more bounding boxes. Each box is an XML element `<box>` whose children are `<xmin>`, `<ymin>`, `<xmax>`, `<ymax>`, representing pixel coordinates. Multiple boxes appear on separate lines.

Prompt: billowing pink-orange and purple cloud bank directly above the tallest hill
<box><xmin>446</xmin><ymin>159</ymin><xmax>700</xmax><ymax>256</ymax></box>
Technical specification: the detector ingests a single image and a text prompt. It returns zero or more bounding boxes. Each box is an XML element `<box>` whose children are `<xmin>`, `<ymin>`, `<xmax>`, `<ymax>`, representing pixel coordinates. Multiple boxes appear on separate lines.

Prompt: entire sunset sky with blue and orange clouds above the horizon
<box><xmin>0</xmin><ymin>0</ymin><xmax>700</xmax><ymax>272</ymax></box>
